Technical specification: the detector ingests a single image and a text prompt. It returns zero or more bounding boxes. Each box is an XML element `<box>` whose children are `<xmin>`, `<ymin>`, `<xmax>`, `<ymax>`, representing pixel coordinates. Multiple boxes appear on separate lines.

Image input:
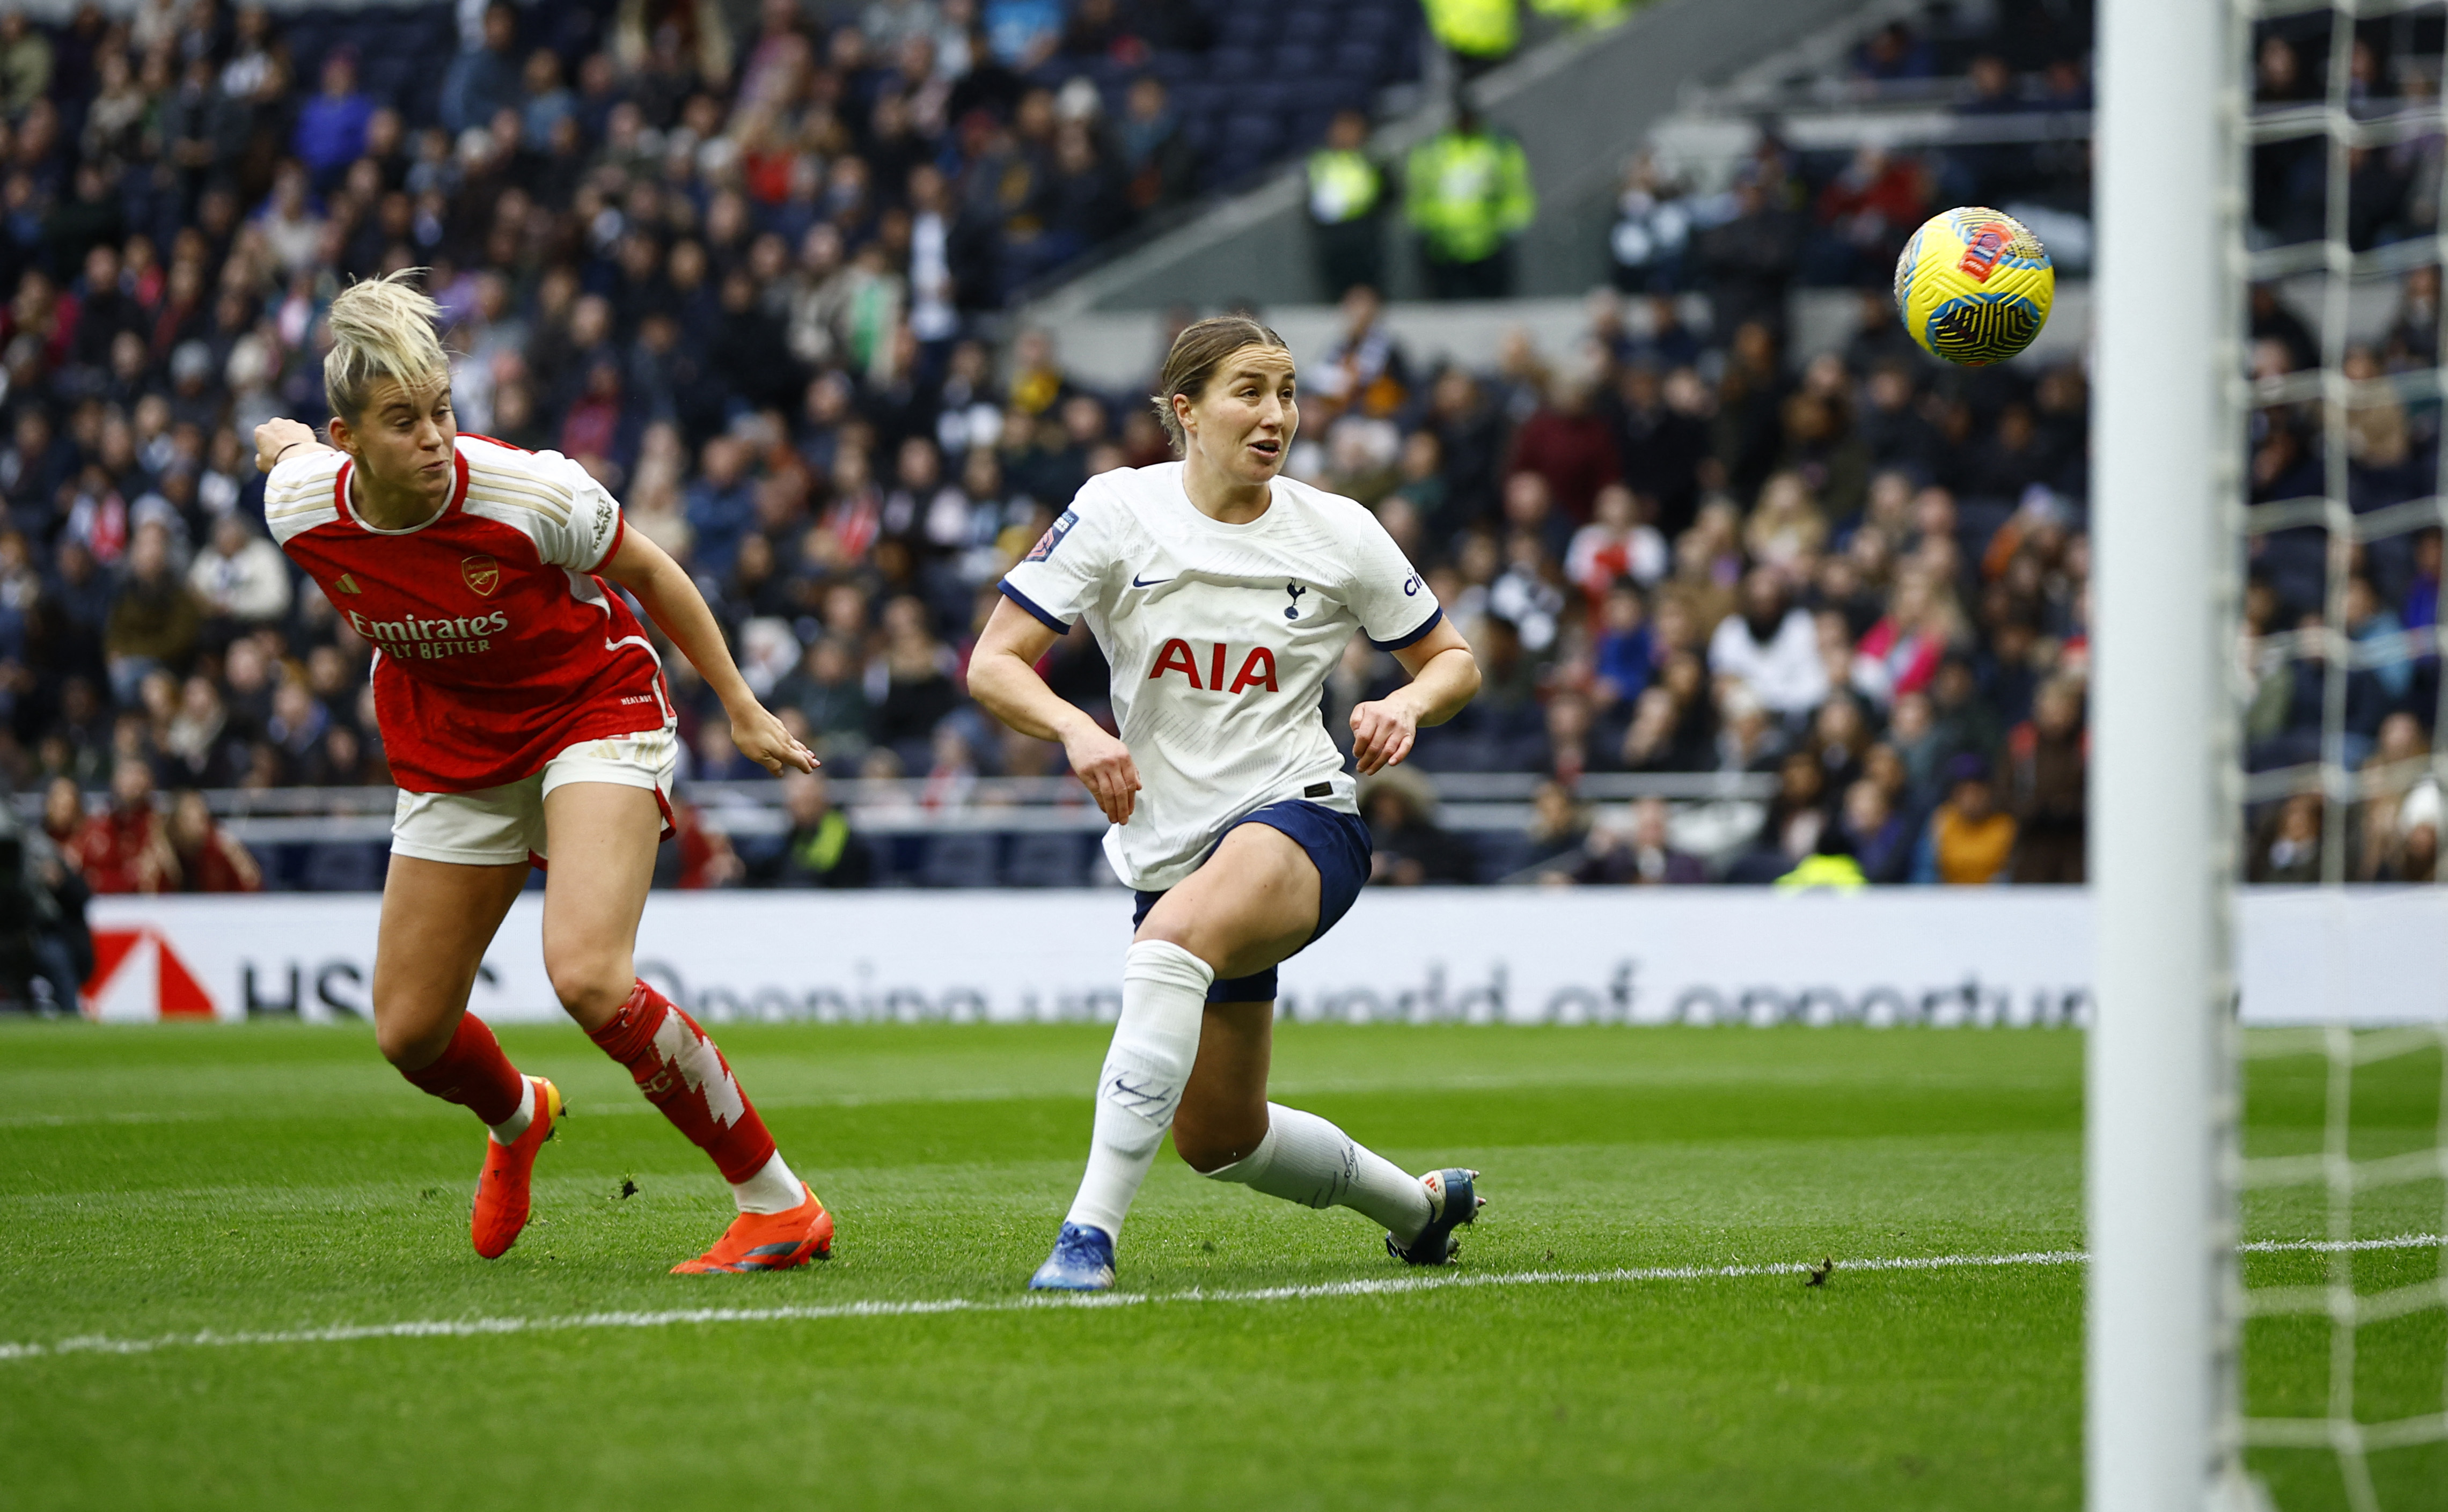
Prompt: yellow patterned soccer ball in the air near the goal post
<box><xmin>1895</xmin><ymin>205</ymin><xmax>2056</xmax><ymax>367</ymax></box>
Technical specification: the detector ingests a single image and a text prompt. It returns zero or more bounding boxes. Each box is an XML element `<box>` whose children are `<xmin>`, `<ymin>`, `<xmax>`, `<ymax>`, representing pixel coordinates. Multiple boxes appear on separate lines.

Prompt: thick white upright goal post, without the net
<box><xmin>2083</xmin><ymin>0</ymin><xmax>2242</xmax><ymax>1512</ymax></box>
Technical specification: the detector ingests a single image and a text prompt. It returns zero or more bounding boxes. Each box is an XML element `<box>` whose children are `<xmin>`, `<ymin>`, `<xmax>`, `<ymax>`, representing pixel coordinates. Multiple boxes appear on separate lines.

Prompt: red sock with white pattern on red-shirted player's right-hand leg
<box><xmin>588</xmin><ymin>981</ymin><xmax>808</xmax><ymax>1214</ymax></box>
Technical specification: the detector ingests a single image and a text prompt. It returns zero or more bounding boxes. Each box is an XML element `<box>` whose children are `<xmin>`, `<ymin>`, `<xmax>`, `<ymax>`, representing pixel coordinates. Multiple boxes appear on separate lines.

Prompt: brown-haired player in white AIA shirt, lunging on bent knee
<box><xmin>970</xmin><ymin>315</ymin><xmax>1481</xmax><ymax>1292</ymax></box>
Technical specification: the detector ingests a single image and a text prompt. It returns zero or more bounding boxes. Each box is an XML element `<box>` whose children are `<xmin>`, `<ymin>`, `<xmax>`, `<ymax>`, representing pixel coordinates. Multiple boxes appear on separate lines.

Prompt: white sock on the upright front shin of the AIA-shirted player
<box><xmin>1067</xmin><ymin>940</ymin><xmax>1216</xmax><ymax>1238</ymax></box>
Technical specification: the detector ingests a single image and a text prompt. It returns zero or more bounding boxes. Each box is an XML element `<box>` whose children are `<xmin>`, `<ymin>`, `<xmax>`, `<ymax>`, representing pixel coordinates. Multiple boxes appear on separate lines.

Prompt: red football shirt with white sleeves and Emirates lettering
<box><xmin>265</xmin><ymin>436</ymin><xmax>671</xmax><ymax>792</ymax></box>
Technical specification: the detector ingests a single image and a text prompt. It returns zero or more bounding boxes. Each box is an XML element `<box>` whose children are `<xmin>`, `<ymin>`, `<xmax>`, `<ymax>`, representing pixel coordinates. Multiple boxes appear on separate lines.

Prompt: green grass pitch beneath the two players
<box><xmin>0</xmin><ymin>1025</ymin><xmax>2448</xmax><ymax>1512</ymax></box>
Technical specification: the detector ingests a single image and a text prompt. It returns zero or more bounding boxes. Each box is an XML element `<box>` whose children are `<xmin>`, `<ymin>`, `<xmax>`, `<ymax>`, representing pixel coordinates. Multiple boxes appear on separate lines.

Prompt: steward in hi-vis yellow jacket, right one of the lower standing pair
<box><xmin>1403</xmin><ymin>104</ymin><xmax>1537</xmax><ymax>298</ymax></box>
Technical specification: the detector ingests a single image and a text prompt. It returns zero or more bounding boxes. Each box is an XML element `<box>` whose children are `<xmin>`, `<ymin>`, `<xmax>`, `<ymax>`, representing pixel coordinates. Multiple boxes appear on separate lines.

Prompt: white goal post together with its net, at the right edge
<box><xmin>2088</xmin><ymin>0</ymin><xmax>2448</xmax><ymax>1512</ymax></box>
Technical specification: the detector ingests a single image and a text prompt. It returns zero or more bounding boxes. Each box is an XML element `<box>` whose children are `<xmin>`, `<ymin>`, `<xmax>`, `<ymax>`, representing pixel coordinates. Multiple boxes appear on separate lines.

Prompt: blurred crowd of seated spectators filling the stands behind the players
<box><xmin>0</xmin><ymin>0</ymin><xmax>2440</xmax><ymax>891</ymax></box>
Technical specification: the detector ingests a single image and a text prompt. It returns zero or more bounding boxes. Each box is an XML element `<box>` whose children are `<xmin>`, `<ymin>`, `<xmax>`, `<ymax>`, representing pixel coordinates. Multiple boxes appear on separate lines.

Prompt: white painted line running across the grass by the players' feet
<box><xmin>0</xmin><ymin>1233</ymin><xmax>2448</xmax><ymax>1360</ymax></box>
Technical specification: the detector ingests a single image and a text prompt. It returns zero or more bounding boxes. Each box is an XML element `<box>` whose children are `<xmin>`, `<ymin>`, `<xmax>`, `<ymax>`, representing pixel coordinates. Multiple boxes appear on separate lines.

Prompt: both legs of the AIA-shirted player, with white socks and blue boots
<box><xmin>1031</xmin><ymin>825</ymin><xmax>1476</xmax><ymax>1292</ymax></box>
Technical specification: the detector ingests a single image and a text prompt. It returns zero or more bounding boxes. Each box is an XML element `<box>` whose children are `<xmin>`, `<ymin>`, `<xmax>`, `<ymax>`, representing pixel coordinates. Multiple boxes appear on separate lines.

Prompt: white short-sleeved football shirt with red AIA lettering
<box><xmin>1003</xmin><ymin>463</ymin><xmax>1445</xmax><ymax>893</ymax></box>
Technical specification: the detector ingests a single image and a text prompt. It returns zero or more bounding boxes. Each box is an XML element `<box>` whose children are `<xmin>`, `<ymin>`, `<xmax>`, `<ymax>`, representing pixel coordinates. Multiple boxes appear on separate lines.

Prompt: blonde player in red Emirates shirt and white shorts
<box><xmin>254</xmin><ymin>274</ymin><xmax>832</xmax><ymax>1272</ymax></box>
